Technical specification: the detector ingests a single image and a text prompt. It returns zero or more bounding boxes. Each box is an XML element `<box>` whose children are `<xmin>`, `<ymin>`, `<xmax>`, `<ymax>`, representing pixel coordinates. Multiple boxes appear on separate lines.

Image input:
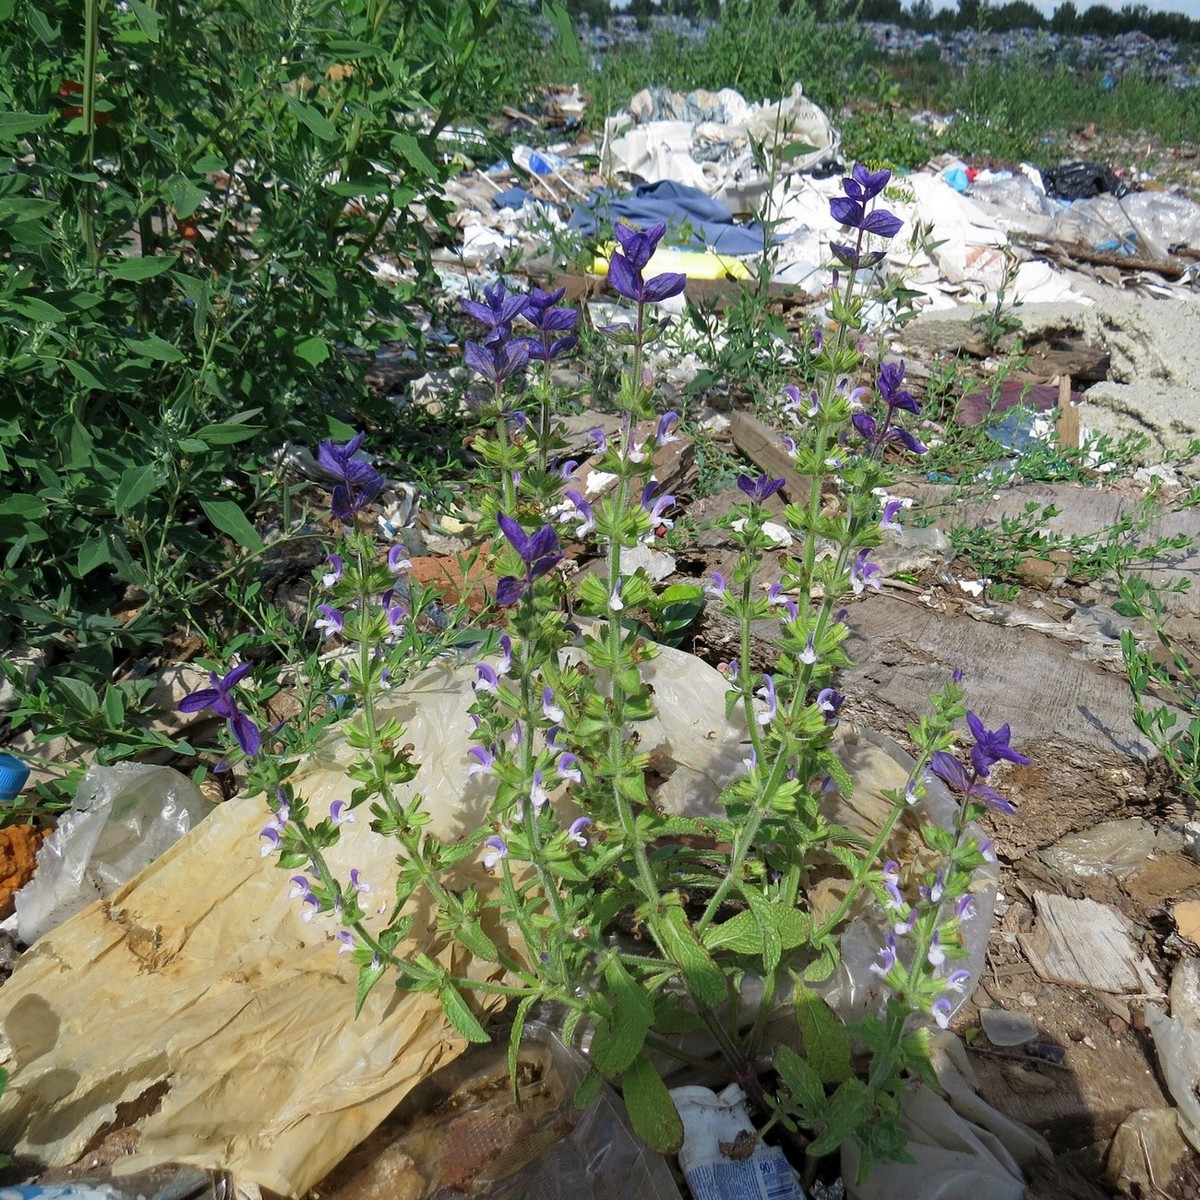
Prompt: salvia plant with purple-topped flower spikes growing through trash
<box><xmin>185</xmin><ymin>166</ymin><xmax>1028</xmax><ymax>1170</ymax></box>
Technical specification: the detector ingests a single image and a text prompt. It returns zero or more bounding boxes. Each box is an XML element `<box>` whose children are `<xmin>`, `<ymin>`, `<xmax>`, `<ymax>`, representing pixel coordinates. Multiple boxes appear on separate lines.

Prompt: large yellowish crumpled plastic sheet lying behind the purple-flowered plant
<box><xmin>0</xmin><ymin>648</ymin><xmax>988</xmax><ymax>1195</ymax></box>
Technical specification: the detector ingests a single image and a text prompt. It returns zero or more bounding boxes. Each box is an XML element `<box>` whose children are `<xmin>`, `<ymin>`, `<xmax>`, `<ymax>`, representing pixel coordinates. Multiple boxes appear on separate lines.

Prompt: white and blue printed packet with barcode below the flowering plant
<box><xmin>671</xmin><ymin>1084</ymin><xmax>804</xmax><ymax>1200</ymax></box>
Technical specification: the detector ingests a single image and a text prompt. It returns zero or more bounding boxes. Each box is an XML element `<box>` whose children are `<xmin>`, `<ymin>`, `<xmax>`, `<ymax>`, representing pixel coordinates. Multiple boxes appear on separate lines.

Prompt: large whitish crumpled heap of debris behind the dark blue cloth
<box><xmin>600</xmin><ymin>82</ymin><xmax>841</xmax><ymax>211</ymax></box>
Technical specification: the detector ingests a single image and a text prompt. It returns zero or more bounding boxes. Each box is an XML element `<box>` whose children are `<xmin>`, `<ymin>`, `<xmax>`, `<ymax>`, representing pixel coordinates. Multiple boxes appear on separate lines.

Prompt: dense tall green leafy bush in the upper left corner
<box><xmin>0</xmin><ymin>0</ymin><xmax>496</xmax><ymax>700</ymax></box>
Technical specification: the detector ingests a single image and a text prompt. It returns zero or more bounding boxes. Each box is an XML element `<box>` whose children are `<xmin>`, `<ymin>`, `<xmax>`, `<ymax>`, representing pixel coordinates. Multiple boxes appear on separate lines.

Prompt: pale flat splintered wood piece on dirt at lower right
<box><xmin>1019</xmin><ymin>892</ymin><xmax>1162</xmax><ymax>996</ymax></box>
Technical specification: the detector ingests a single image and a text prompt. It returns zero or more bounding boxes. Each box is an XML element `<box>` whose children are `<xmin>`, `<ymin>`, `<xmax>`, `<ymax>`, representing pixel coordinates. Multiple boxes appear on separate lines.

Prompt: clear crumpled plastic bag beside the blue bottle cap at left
<box><xmin>16</xmin><ymin>763</ymin><xmax>212</xmax><ymax>946</ymax></box>
